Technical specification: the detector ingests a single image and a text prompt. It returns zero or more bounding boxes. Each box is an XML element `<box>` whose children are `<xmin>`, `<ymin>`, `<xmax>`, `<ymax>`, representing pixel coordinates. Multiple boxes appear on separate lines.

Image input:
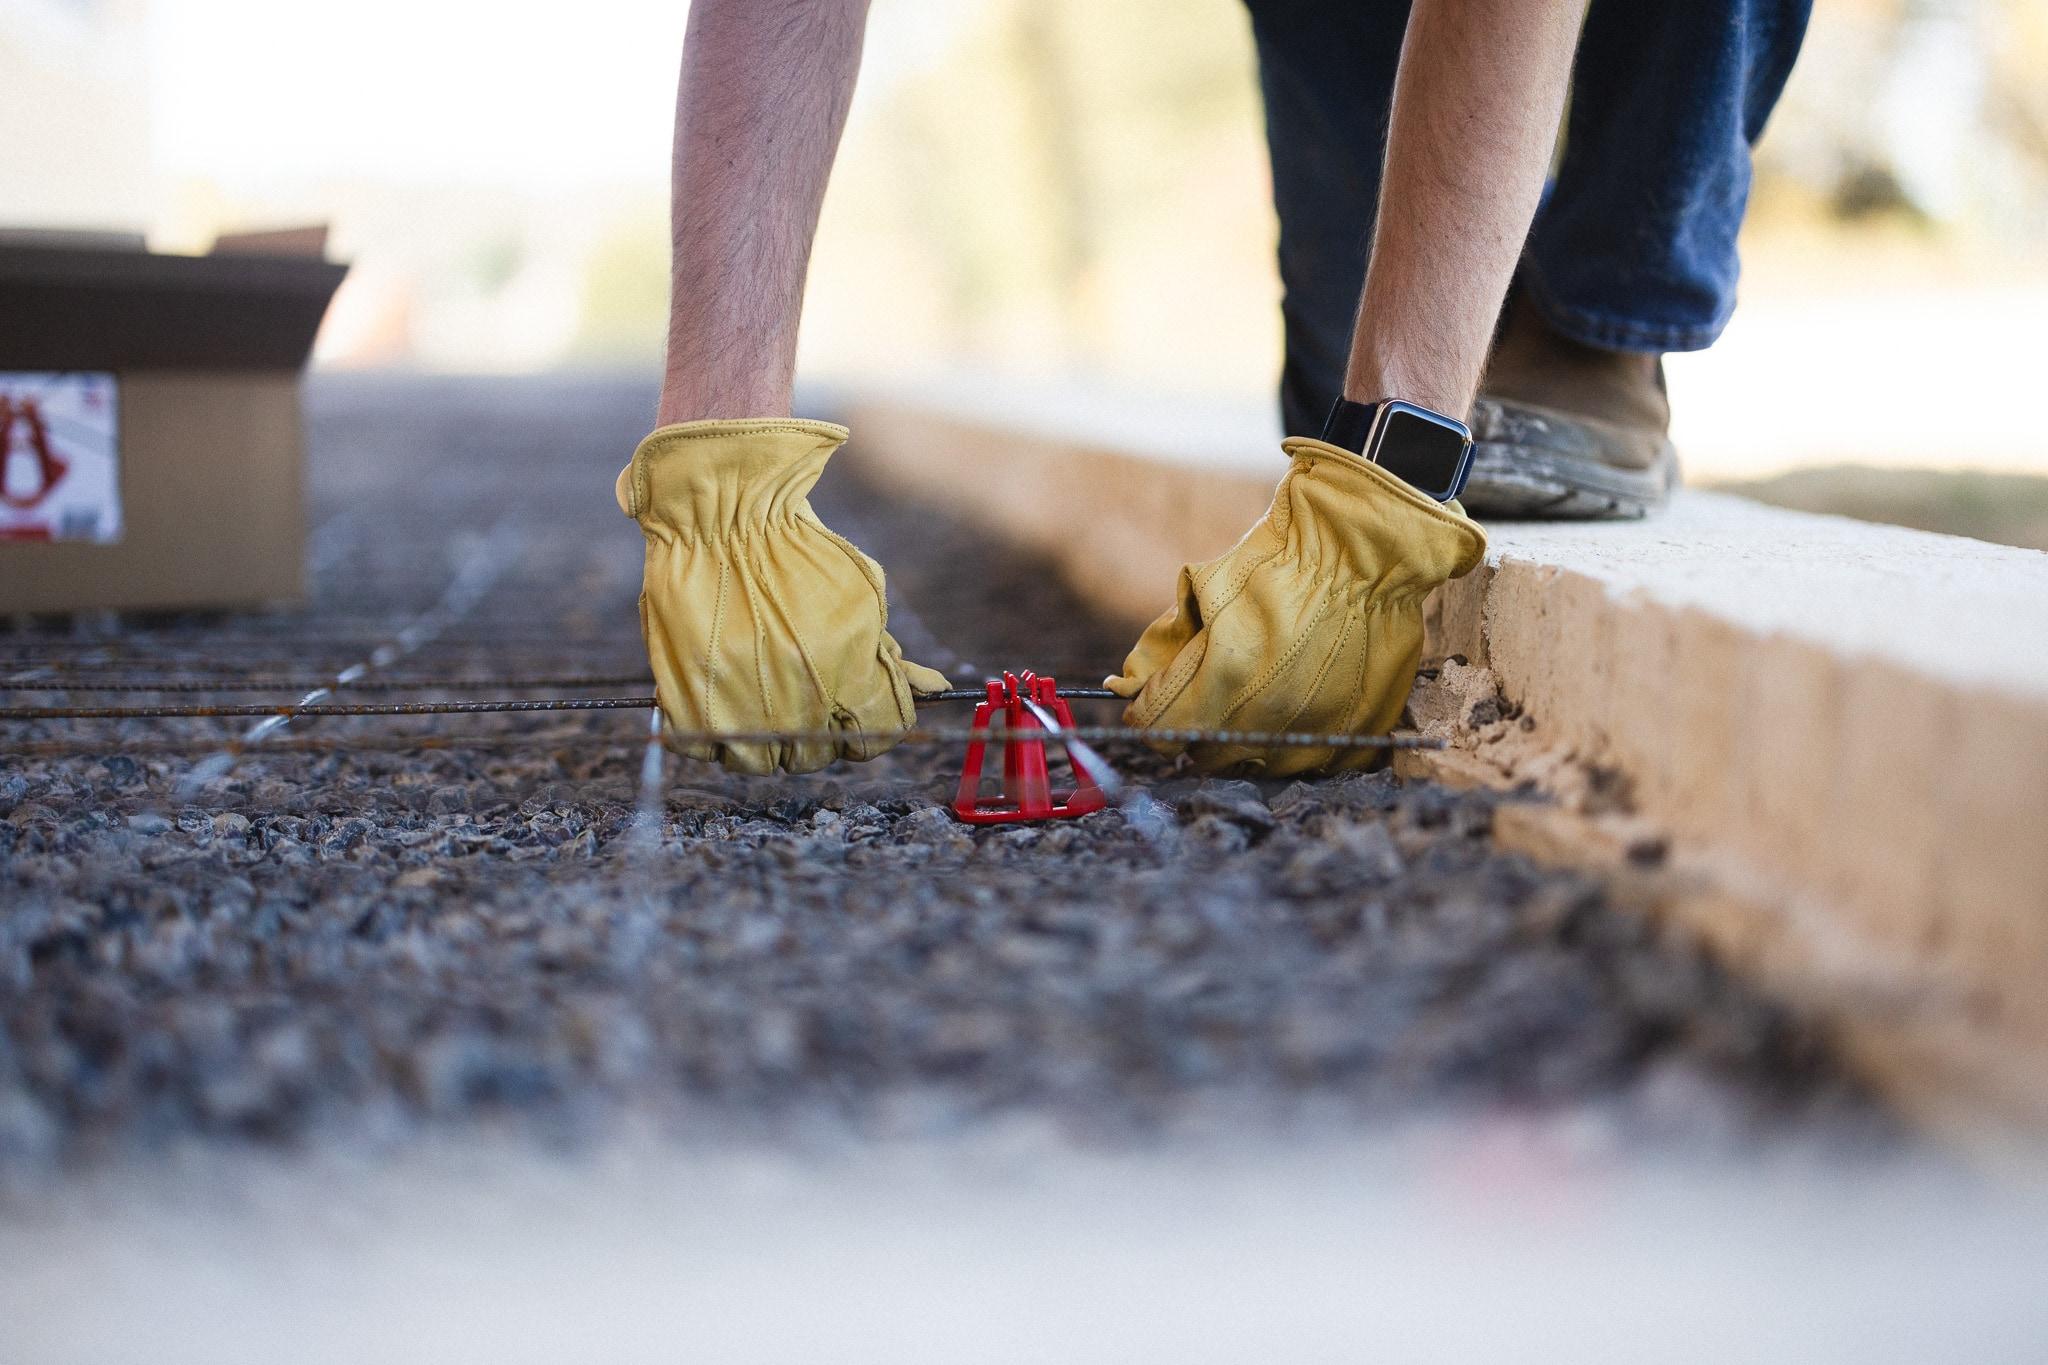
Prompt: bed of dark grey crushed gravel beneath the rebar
<box><xmin>0</xmin><ymin>379</ymin><xmax>1884</xmax><ymax>1179</ymax></box>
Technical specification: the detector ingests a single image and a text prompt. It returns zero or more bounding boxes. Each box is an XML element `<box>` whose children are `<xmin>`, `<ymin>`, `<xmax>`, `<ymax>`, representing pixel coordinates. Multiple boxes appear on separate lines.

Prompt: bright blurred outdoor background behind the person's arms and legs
<box><xmin>12</xmin><ymin>0</ymin><xmax>2048</xmax><ymax>548</ymax></box>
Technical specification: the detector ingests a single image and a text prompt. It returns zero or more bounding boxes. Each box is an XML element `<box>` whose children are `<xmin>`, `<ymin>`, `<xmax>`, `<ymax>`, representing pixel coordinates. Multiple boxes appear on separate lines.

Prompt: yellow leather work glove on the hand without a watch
<box><xmin>614</xmin><ymin>417</ymin><xmax>946</xmax><ymax>774</ymax></box>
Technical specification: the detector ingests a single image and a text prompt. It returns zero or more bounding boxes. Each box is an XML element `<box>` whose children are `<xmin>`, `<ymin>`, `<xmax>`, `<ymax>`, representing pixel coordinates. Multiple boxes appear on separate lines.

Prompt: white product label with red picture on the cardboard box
<box><xmin>0</xmin><ymin>370</ymin><xmax>121</xmax><ymax>544</ymax></box>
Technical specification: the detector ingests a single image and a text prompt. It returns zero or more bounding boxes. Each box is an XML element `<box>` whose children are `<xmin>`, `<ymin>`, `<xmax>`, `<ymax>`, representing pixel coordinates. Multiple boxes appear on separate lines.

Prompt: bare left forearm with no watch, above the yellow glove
<box><xmin>659</xmin><ymin>0</ymin><xmax>868</xmax><ymax>424</ymax></box>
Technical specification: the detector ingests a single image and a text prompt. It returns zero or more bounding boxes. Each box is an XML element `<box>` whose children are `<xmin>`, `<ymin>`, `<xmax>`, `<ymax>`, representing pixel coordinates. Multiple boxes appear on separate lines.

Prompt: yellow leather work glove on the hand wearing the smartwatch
<box><xmin>1104</xmin><ymin>438</ymin><xmax>1487</xmax><ymax>778</ymax></box>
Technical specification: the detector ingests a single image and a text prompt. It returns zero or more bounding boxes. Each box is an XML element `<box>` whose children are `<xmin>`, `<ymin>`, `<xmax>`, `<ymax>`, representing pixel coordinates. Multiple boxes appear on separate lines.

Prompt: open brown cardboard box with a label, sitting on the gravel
<box><xmin>0</xmin><ymin>229</ymin><xmax>346</xmax><ymax>614</ymax></box>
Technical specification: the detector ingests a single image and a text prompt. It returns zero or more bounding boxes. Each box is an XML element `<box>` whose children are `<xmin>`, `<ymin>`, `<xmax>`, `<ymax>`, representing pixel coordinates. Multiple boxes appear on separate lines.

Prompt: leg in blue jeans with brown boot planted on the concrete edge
<box><xmin>1466</xmin><ymin>0</ymin><xmax>1810</xmax><ymax>516</ymax></box>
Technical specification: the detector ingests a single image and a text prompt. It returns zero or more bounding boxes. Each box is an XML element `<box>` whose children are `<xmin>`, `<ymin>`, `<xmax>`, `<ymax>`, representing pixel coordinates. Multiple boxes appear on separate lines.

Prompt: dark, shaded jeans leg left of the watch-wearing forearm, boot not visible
<box><xmin>1247</xmin><ymin>0</ymin><xmax>1407</xmax><ymax>436</ymax></box>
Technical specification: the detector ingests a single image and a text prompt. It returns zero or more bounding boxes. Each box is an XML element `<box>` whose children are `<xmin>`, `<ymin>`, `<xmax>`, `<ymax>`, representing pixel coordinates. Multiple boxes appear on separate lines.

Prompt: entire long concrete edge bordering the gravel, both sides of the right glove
<box><xmin>844</xmin><ymin>395</ymin><xmax>2048</xmax><ymax>1156</ymax></box>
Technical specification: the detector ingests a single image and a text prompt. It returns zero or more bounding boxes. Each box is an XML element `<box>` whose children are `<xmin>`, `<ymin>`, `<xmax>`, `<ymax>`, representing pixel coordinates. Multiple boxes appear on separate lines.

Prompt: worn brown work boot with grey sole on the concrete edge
<box><xmin>1458</xmin><ymin>299</ymin><xmax>1677</xmax><ymax>520</ymax></box>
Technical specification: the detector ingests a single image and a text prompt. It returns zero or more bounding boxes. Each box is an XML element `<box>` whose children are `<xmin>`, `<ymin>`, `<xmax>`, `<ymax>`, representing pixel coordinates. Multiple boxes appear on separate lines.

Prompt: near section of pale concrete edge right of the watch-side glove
<box><xmin>1438</xmin><ymin>493</ymin><xmax>2048</xmax><ymax>1130</ymax></box>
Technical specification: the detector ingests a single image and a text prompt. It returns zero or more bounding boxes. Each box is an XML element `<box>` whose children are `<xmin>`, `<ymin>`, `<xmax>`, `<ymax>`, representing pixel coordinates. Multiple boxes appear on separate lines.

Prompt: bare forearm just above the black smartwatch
<box><xmin>1343</xmin><ymin>0</ymin><xmax>1587</xmax><ymax>417</ymax></box>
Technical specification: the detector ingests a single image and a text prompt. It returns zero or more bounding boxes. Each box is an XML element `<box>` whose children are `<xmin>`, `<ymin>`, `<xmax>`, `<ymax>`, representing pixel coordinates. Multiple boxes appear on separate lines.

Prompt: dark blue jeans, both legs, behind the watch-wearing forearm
<box><xmin>1247</xmin><ymin>0</ymin><xmax>1812</xmax><ymax>432</ymax></box>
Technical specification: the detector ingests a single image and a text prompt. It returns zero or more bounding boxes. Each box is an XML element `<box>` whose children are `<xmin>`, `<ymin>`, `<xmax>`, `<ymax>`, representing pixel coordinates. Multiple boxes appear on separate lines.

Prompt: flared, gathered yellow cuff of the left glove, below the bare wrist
<box><xmin>612</xmin><ymin>417</ymin><xmax>848</xmax><ymax>540</ymax></box>
